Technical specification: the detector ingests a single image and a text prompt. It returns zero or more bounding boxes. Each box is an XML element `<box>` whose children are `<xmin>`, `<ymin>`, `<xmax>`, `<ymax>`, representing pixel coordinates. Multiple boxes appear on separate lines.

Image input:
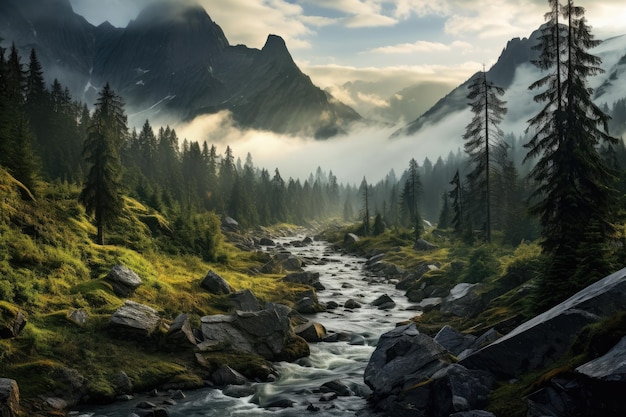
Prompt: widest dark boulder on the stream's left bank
<box><xmin>201</xmin><ymin>306</ymin><xmax>309</xmax><ymax>361</ymax></box>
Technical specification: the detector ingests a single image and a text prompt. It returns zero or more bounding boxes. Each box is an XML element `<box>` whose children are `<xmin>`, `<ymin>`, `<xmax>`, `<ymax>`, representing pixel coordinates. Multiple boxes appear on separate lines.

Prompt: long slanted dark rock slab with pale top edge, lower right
<box><xmin>460</xmin><ymin>269</ymin><xmax>626</xmax><ymax>379</ymax></box>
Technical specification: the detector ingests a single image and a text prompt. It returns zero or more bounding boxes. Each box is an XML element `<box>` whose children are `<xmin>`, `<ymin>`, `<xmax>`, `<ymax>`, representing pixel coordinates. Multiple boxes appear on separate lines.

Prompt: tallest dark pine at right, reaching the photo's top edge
<box><xmin>526</xmin><ymin>0</ymin><xmax>617</xmax><ymax>307</ymax></box>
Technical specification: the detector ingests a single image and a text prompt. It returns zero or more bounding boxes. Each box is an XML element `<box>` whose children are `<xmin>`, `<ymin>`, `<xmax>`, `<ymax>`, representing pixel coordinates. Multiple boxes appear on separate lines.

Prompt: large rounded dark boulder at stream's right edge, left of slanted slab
<box><xmin>363</xmin><ymin>323</ymin><xmax>451</xmax><ymax>400</ymax></box>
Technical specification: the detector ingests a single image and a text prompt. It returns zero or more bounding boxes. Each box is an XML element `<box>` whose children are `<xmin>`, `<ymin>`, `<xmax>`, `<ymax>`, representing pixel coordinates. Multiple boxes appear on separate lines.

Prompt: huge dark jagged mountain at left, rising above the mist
<box><xmin>0</xmin><ymin>0</ymin><xmax>361</xmax><ymax>138</ymax></box>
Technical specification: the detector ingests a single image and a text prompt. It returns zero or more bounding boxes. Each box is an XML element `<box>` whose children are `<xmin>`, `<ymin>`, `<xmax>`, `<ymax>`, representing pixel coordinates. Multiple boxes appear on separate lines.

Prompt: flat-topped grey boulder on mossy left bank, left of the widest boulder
<box><xmin>109</xmin><ymin>300</ymin><xmax>161</xmax><ymax>340</ymax></box>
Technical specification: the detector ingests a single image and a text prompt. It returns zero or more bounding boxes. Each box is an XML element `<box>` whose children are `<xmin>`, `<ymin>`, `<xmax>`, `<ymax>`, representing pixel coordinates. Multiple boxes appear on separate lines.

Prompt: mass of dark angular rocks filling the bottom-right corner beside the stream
<box><xmin>364</xmin><ymin>269</ymin><xmax>626</xmax><ymax>417</ymax></box>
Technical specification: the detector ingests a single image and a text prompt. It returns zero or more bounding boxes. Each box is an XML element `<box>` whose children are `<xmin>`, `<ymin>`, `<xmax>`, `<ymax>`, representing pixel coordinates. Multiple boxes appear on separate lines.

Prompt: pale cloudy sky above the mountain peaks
<box><xmin>70</xmin><ymin>0</ymin><xmax>626</xmax><ymax>92</ymax></box>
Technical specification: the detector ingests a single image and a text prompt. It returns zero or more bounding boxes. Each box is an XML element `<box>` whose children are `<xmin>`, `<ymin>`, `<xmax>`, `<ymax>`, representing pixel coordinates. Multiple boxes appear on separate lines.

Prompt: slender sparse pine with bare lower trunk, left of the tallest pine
<box><xmin>463</xmin><ymin>71</ymin><xmax>507</xmax><ymax>243</ymax></box>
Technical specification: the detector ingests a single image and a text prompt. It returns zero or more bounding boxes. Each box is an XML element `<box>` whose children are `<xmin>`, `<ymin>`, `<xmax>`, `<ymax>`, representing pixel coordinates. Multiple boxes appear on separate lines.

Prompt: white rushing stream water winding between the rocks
<box><xmin>73</xmin><ymin>236</ymin><xmax>417</xmax><ymax>417</ymax></box>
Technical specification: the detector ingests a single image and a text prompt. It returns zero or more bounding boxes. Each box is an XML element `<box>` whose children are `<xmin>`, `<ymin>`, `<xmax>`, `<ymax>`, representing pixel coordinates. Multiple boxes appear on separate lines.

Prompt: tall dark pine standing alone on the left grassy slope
<box><xmin>80</xmin><ymin>83</ymin><xmax>128</xmax><ymax>245</ymax></box>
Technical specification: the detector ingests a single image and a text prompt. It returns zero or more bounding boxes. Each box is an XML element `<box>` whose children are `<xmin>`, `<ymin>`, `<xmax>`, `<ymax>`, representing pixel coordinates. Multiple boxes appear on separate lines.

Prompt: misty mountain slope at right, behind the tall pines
<box><xmin>392</xmin><ymin>30</ymin><xmax>626</xmax><ymax>144</ymax></box>
